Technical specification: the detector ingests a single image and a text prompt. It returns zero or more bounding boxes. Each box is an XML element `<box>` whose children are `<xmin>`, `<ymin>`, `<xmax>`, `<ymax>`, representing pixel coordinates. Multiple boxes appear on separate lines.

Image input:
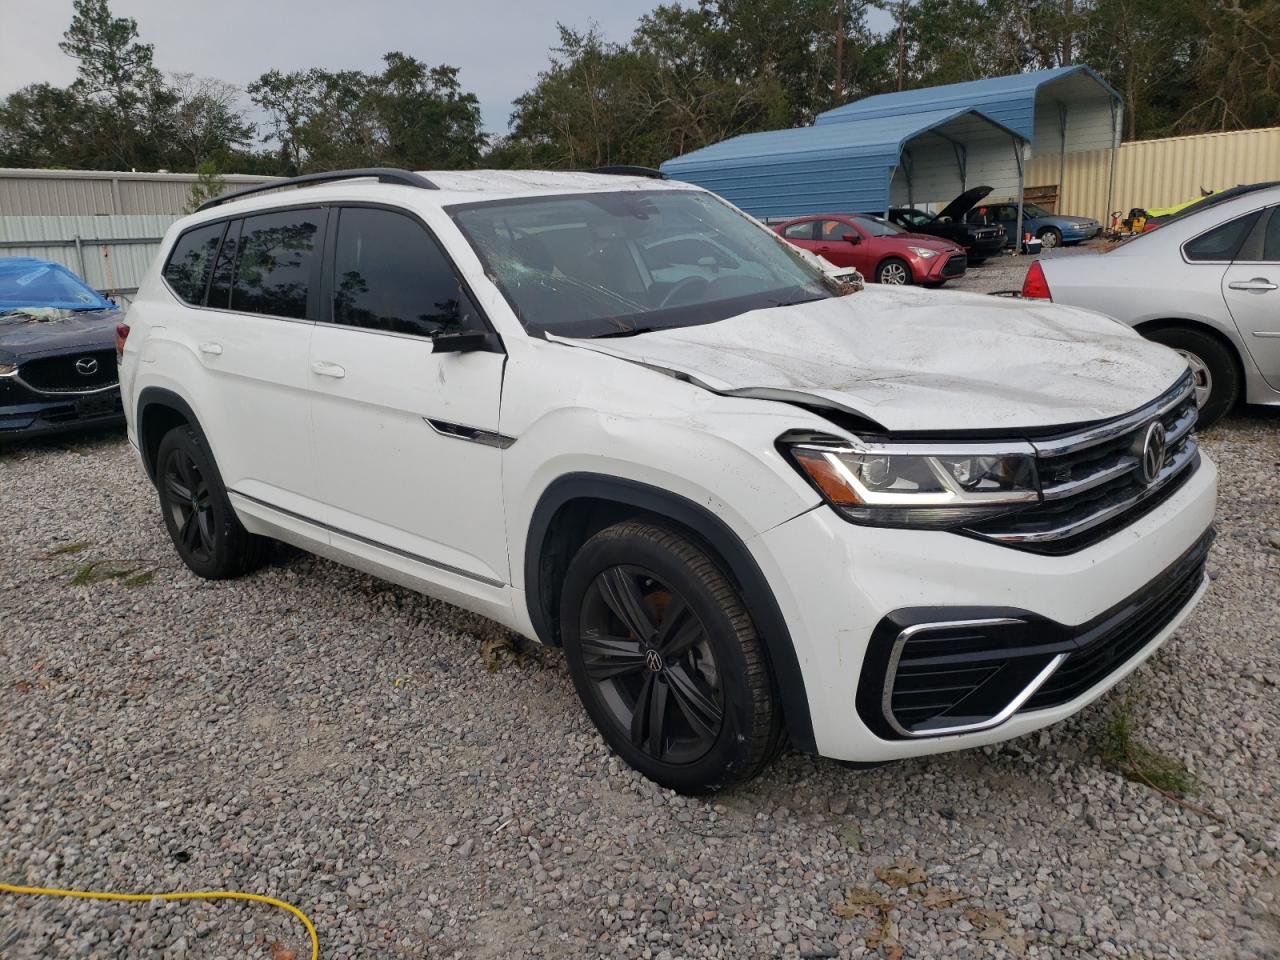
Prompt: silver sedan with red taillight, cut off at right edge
<box><xmin>1023</xmin><ymin>183</ymin><xmax>1280</xmax><ymax>426</ymax></box>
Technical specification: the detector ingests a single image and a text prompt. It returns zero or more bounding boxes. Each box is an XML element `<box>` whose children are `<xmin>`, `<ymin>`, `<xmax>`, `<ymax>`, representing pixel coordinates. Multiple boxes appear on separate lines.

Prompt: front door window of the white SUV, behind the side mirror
<box><xmin>333</xmin><ymin>207</ymin><xmax>481</xmax><ymax>337</ymax></box>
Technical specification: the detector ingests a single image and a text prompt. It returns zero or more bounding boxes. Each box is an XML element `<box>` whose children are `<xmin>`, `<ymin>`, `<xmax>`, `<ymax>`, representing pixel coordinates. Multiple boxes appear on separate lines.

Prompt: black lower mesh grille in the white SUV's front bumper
<box><xmin>1021</xmin><ymin>532</ymin><xmax>1213</xmax><ymax>710</ymax></box>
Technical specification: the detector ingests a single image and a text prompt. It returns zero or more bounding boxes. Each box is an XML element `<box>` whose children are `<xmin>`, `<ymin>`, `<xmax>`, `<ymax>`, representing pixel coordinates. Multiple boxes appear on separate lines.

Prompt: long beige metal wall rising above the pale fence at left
<box><xmin>0</xmin><ymin>169</ymin><xmax>274</xmax><ymax>216</ymax></box>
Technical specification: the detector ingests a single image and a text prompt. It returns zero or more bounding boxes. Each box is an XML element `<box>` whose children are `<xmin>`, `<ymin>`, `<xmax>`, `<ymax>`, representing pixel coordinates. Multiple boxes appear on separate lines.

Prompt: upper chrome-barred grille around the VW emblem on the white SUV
<box><xmin>969</xmin><ymin>374</ymin><xmax>1199</xmax><ymax>554</ymax></box>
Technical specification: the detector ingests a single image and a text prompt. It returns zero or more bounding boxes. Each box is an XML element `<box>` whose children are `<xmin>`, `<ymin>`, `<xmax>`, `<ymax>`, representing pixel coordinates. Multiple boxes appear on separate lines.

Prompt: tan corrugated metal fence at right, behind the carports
<box><xmin>1027</xmin><ymin>127</ymin><xmax>1280</xmax><ymax>223</ymax></box>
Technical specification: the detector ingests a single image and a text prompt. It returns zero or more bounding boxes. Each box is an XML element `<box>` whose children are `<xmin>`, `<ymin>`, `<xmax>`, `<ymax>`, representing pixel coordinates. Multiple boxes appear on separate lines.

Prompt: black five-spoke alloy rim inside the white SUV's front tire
<box><xmin>579</xmin><ymin>564</ymin><xmax>724</xmax><ymax>763</ymax></box>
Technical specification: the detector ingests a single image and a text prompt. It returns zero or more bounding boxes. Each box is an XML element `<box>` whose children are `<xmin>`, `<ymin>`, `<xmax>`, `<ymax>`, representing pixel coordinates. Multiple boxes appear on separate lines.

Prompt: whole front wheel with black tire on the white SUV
<box><xmin>561</xmin><ymin>521</ymin><xmax>783</xmax><ymax>794</ymax></box>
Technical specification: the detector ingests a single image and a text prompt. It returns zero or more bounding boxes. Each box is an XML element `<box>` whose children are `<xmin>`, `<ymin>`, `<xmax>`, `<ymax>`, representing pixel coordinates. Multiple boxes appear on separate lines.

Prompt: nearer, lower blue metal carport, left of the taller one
<box><xmin>662</xmin><ymin>108</ymin><xmax>1025</xmax><ymax>218</ymax></box>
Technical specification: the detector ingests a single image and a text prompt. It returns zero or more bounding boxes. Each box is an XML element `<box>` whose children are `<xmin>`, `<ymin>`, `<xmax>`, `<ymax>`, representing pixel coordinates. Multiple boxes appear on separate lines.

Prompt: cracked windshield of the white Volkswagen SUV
<box><xmin>449</xmin><ymin>189</ymin><xmax>833</xmax><ymax>337</ymax></box>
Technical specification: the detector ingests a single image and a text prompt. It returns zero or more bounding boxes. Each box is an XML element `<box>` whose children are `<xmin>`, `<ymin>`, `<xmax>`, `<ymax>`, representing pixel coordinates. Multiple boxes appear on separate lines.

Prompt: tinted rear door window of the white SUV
<box><xmin>232</xmin><ymin>210</ymin><xmax>324</xmax><ymax>320</ymax></box>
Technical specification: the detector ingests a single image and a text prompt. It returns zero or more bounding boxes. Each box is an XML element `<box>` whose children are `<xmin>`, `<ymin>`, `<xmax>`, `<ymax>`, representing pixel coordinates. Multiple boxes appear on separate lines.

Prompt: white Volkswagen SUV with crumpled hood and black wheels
<box><xmin>120</xmin><ymin>169</ymin><xmax>1216</xmax><ymax>792</ymax></box>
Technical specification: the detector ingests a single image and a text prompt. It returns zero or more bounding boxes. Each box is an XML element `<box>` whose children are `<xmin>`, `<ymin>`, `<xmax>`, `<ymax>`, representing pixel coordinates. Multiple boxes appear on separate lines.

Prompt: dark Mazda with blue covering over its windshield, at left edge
<box><xmin>0</xmin><ymin>257</ymin><xmax>124</xmax><ymax>443</ymax></box>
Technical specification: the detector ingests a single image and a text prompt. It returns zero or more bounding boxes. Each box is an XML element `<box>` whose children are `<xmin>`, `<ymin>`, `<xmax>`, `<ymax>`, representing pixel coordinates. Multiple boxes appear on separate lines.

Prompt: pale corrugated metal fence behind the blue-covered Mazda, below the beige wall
<box><xmin>0</xmin><ymin>214</ymin><xmax>178</xmax><ymax>303</ymax></box>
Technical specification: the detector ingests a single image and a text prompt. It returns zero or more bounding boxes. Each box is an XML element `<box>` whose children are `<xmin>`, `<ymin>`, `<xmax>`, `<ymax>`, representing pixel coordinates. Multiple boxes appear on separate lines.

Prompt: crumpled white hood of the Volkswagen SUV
<box><xmin>553</xmin><ymin>288</ymin><xmax>1187</xmax><ymax>431</ymax></box>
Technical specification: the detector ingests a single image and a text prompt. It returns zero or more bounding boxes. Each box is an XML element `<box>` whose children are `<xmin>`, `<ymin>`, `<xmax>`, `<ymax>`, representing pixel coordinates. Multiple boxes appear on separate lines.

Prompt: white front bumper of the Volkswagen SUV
<box><xmin>753</xmin><ymin>457</ymin><xmax>1217</xmax><ymax>762</ymax></box>
